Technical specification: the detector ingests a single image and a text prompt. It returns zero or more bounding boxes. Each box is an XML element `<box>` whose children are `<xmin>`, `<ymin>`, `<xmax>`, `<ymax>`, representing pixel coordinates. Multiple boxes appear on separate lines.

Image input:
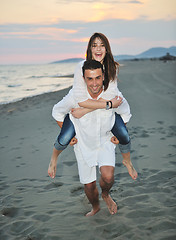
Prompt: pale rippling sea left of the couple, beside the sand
<box><xmin>0</xmin><ymin>62</ymin><xmax>77</xmax><ymax>104</ymax></box>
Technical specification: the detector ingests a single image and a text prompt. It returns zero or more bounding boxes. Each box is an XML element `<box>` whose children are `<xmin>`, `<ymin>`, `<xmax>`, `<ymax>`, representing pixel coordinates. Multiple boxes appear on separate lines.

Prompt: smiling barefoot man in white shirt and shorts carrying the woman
<box><xmin>50</xmin><ymin>60</ymin><xmax>128</xmax><ymax>216</ymax></box>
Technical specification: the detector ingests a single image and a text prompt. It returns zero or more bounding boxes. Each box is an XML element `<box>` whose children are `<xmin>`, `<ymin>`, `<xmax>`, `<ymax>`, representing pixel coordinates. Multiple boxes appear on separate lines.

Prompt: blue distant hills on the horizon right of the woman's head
<box><xmin>114</xmin><ymin>46</ymin><xmax>176</xmax><ymax>60</ymax></box>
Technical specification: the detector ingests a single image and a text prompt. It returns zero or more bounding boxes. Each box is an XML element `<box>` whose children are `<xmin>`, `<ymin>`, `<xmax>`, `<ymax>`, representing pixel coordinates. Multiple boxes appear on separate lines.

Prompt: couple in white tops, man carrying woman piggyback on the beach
<box><xmin>48</xmin><ymin>33</ymin><xmax>137</xmax><ymax>216</ymax></box>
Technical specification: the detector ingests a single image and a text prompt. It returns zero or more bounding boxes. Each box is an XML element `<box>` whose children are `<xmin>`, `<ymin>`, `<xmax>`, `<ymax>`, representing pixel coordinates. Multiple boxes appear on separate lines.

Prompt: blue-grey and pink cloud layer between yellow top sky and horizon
<box><xmin>0</xmin><ymin>19</ymin><xmax>176</xmax><ymax>62</ymax></box>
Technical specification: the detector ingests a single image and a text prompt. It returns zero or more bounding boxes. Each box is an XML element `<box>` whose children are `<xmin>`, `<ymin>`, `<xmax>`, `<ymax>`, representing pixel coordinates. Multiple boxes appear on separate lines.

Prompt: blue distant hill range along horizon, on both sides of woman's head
<box><xmin>51</xmin><ymin>46</ymin><xmax>176</xmax><ymax>64</ymax></box>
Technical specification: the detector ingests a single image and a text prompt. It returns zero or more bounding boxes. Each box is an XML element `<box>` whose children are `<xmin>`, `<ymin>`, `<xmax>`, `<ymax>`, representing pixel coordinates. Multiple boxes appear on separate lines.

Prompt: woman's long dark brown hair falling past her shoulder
<box><xmin>86</xmin><ymin>33</ymin><xmax>119</xmax><ymax>91</ymax></box>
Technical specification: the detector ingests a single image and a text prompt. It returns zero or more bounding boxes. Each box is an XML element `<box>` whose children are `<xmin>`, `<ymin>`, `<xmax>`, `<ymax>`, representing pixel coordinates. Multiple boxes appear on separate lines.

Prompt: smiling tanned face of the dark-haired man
<box><xmin>84</xmin><ymin>68</ymin><xmax>104</xmax><ymax>98</ymax></box>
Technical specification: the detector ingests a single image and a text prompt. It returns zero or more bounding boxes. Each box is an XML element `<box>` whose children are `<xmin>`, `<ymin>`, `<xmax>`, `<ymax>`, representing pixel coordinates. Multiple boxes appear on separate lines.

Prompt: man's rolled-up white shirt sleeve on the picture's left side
<box><xmin>52</xmin><ymin>89</ymin><xmax>75</xmax><ymax>122</ymax></box>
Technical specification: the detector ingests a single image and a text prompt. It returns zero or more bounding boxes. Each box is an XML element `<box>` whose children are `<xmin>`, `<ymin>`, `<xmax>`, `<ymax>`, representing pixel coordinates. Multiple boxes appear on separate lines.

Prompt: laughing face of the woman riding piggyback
<box><xmin>91</xmin><ymin>38</ymin><xmax>106</xmax><ymax>63</ymax></box>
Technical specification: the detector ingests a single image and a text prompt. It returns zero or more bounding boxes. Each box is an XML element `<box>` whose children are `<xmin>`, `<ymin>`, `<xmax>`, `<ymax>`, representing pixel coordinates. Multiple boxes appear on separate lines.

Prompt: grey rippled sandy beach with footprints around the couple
<box><xmin>0</xmin><ymin>60</ymin><xmax>176</xmax><ymax>240</ymax></box>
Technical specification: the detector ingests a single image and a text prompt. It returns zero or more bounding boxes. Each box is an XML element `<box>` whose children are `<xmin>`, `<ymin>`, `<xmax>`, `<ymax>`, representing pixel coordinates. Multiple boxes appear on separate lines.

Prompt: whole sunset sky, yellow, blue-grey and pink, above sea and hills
<box><xmin>0</xmin><ymin>0</ymin><xmax>176</xmax><ymax>64</ymax></box>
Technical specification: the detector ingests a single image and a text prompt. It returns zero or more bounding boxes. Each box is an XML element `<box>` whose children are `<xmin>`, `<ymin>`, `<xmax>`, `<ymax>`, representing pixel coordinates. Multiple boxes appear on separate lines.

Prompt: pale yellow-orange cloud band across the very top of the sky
<box><xmin>0</xmin><ymin>0</ymin><xmax>176</xmax><ymax>25</ymax></box>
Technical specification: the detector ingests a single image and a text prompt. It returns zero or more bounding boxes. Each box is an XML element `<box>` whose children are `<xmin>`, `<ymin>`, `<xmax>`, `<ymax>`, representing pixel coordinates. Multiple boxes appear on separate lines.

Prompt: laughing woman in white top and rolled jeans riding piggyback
<box><xmin>48</xmin><ymin>33</ymin><xmax>137</xmax><ymax>179</ymax></box>
